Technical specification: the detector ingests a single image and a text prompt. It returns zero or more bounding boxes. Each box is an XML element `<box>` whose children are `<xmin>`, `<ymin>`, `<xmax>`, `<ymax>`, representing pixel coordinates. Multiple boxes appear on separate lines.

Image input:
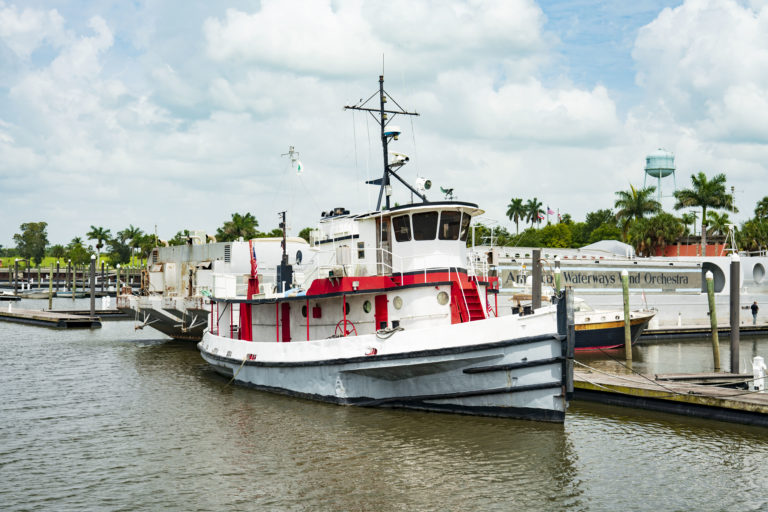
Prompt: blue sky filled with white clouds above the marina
<box><xmin>0</xmin><ymin>0</ymin><xmax>768</xmax><ymax>247</ymax></box>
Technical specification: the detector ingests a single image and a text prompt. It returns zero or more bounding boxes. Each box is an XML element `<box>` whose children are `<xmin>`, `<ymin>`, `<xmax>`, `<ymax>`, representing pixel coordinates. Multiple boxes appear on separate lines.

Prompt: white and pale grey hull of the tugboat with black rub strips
<box><xmin>198</xmin><ymin>313</ymin><xmax>567</xmax><ymax>422</ymax></box>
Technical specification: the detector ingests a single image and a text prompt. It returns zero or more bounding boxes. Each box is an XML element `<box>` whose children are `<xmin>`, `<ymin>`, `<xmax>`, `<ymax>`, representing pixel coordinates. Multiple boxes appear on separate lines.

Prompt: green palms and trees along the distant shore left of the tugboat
<box><xmin>0</xmin><ymin>213</ymin><xmax>310</xmax><ymax>266</ymax></box>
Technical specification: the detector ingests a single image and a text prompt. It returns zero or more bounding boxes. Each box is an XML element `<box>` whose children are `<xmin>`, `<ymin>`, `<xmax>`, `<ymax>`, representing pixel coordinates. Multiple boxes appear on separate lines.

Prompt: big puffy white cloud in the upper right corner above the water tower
<box><xmin>633</xmin><ymin>0</ymin><xmax>768</xmax><ymax>142</ymax></box>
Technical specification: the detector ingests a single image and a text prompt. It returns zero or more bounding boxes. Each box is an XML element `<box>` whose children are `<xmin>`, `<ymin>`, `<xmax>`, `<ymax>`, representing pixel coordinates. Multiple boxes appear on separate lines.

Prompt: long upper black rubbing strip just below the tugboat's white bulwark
<box><xmin>200</xmin><ymin>333</ymin><xmax>560</xmax><ymax>368</ymax></box>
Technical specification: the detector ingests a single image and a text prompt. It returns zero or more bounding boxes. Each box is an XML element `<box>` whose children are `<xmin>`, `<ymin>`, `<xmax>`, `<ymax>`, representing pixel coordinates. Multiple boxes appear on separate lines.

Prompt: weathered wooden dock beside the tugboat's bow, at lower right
<box><xmin>574</xmin><ymin>368</ymin><xmax>768</xmax><ymax>426</ymax></box>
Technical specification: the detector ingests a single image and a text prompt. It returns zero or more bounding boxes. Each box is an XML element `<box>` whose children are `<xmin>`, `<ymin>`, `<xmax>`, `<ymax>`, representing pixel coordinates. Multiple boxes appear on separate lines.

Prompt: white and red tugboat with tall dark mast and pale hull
<box><xmin>198</xmin><ymin>76</ymin><xmax>573</xmax><ymax>422</ymax></box>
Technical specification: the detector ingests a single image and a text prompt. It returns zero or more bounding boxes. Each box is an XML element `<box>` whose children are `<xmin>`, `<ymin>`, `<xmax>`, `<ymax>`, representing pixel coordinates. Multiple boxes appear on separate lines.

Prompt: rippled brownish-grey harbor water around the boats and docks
<box><xmin>0</xmin><ymin>300</ymin><xmax>768</xmax><ymax>511</ymax></box>
